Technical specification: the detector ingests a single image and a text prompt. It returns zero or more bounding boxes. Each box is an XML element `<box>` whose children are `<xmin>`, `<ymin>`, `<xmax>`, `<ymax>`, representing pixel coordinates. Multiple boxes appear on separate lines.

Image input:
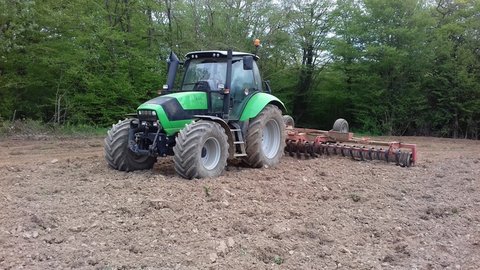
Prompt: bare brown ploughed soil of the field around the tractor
<box><xmin>0</xmin><ymin>137</ymin><xmax>480</xmax><ymax>269</ymax></box>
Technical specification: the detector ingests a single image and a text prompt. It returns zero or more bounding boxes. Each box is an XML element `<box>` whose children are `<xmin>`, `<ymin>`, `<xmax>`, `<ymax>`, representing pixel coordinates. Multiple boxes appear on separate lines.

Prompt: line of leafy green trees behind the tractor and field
<box><xmin>0</xmin><ymin>0</ymin><xmax>480</xmax><ymax>139</ymax></box>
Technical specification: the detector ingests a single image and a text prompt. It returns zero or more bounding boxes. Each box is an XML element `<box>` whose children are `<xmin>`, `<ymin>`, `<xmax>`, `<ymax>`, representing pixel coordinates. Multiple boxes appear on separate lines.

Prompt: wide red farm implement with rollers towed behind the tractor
<box><xmin>284</xmin><ymin>116</ymin><xmax>417</xmax><ymax>167</ymax></box>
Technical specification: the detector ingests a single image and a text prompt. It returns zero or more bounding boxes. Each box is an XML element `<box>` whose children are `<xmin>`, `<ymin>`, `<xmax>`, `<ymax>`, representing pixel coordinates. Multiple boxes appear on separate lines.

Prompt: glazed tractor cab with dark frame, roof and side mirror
<box><xmin>166</xmin><ymin>51</ymin><xmax>263</xmax><ymax>120</ymax></box>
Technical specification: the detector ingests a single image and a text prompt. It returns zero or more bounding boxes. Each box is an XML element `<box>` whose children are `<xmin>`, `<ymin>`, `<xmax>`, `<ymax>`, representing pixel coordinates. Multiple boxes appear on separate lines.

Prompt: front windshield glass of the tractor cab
<box><xmin>182</xmin><ymin>59</ymin><xmax>227</xmax><ymax>91</ymax></box>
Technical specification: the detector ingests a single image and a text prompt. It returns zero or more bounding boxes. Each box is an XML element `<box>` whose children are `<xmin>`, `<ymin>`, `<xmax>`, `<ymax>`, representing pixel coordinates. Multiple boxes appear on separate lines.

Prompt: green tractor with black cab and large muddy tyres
<box><xmin>105</xmin><ymin>50</ymin><xmax>285</xmax><ymax>179</ymax></box>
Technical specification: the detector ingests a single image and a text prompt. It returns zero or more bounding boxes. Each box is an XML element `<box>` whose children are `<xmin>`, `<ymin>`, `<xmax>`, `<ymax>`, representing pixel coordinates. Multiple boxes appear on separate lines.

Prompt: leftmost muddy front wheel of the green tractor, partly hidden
<box><xmin>104</xmin><ymin>119</ymin><xmax>157</xmax><ymax>172</ymax></box>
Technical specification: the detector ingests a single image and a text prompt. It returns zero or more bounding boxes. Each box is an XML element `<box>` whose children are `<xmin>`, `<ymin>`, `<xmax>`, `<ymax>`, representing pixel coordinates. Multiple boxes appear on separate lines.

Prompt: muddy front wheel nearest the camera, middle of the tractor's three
<box><xmin>173</xmin><ymin>120</ymin><xmax>228</xmax><ymax>179</ymax></box>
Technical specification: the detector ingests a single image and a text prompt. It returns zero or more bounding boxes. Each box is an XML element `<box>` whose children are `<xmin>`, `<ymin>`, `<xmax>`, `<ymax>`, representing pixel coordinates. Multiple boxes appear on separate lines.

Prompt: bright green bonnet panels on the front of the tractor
<box><xmin>137</xmin><ymin>92</ymin><xmax>208</xmax><ymax>136</ymax></box>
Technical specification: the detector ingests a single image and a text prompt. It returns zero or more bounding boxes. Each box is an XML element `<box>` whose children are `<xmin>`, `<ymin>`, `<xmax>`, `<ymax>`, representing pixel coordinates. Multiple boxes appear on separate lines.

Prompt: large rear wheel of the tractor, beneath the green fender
<box><xmin>246</xmin><ymin>105</ymin><xmax>285</xmax><ymax>168</ymax></box>
